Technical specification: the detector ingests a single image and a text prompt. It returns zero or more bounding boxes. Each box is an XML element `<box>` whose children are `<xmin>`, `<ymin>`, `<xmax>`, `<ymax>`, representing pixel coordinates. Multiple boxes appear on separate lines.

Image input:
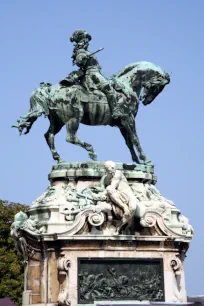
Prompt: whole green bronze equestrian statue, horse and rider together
<box><xmin>11</xmin><ymin>30</ymin><xmax>170</xmax><ymax>164</ymax></box>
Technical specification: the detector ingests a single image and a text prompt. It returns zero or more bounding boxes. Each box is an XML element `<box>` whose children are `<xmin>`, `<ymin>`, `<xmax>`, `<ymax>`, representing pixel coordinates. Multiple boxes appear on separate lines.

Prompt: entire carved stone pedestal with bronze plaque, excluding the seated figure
<box><xmin>12</xmin><ymin>162</ymin><xmax>193</xmax><ymax>306</ymax></box>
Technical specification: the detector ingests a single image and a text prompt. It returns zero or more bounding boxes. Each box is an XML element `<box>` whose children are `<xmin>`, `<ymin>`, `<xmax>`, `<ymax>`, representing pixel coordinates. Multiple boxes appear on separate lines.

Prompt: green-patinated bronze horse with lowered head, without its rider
<box><xmin>14</xmin><ymin>62</ymin><xmax>170</xmax><ymax>164</ymax></box>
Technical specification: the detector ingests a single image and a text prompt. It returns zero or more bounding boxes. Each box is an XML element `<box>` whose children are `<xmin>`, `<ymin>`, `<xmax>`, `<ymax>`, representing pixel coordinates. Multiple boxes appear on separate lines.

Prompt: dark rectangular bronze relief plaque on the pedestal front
<box><xmin>78</xmin><ymin>258</ymin><xmax>165</xmax><ymax>304</ymax></box>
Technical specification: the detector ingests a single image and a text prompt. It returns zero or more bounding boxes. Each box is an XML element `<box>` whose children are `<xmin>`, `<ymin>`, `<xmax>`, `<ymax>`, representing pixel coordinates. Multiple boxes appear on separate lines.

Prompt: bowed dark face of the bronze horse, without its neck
<box><xmin>140</xmin><ymin>73</ymin><xmax>170</xmax><ymax>105</ymax></box>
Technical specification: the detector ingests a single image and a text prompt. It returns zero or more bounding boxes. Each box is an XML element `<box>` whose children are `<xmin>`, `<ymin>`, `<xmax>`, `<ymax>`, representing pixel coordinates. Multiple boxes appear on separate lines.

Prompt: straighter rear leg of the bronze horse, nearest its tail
<box><xmin>45</xmin><ymin>122</ymin><xmax>64</xmax><ymax>162</ymax></box>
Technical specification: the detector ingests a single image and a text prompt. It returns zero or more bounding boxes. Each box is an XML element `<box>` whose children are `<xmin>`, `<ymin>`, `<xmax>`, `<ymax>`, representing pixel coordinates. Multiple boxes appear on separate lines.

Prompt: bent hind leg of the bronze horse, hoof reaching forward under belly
<box><xmin>66</xmin><ymin>118</ymin><xmax>97</xmax><ymax>160</ymax></box>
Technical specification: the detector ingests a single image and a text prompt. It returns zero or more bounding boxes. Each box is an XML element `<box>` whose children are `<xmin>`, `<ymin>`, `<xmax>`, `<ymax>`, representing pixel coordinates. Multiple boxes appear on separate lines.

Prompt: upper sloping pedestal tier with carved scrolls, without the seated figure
<box><xmin>13</xmin><ymin>162</ymin><xmax>193</xmax><ymax>239</ymax></box>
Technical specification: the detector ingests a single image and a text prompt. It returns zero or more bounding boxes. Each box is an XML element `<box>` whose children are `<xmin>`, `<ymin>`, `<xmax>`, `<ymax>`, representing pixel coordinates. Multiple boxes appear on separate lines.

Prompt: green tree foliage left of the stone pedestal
<box><xmin>0</xmin><ymin>200</ymin><xmax>27</xmax><ymax>306</ymax></box>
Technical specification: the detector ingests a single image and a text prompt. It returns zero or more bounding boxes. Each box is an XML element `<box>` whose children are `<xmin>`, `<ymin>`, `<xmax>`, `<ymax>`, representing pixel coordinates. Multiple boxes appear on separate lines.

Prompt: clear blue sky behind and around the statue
<box><xmin>0</xmin><ymin>0</ymin><xmax>204</xmax><ymax>295</ymax></box>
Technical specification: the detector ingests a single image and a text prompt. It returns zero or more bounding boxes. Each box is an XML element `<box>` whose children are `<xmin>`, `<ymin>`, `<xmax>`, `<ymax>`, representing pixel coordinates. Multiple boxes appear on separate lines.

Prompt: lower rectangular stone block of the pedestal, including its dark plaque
<box><xmin>24</xmin><ymin>235</ymin><xmax>188</xmax><ymax>306</ymax></box>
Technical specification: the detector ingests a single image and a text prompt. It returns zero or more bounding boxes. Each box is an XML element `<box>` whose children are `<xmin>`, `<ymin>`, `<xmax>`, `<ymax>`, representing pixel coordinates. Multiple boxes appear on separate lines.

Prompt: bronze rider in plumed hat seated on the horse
<box><xmin>60</xmin><ymin>30</ymin><xmax>133</xmax><ymax>119</ymax></box>
